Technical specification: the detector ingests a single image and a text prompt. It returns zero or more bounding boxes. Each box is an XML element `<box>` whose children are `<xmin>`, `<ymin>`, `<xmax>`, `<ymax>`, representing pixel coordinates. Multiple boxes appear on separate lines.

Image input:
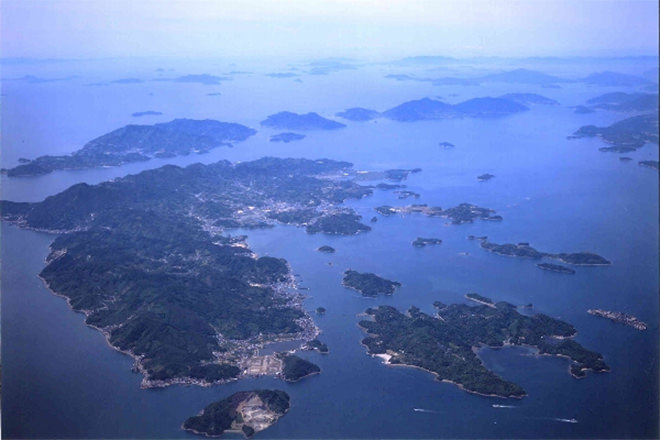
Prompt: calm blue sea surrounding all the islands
<box><xmin>1</xmin><ymin>58</ymin><xmax>659</xmax><ymax>439</ymax></box>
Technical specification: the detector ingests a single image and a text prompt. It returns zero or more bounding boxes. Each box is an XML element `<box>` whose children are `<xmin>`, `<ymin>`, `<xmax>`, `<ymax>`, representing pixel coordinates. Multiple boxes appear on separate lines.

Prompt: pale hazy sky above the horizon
<box><xmin>0</xmin><ymin>0</ymin><xmax>658</xmax><ymax>58</ymax></box>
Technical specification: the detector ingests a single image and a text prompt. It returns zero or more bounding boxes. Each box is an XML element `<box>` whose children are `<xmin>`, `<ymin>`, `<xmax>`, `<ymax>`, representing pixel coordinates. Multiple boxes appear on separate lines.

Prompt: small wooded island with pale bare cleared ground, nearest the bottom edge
<box><xmin>182</xmin><ymin>390</ymin><xmax>290</xmax><ymax>438</ymax></box>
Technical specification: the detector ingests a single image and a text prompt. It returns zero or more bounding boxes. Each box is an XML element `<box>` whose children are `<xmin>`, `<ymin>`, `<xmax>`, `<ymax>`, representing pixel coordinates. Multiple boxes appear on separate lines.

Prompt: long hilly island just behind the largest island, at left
<box><xmin>6</xmin><ymin>119</ymin><xmax>256</xmax><ymax>177</ymax></box>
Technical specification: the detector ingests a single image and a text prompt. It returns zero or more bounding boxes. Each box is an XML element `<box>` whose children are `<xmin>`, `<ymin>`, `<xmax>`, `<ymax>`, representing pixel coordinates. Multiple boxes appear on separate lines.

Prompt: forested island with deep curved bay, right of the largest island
<box><xmin>359</xmin><ymin>294</ymin><xmax>608</xmax><ymax>397</ymax></box>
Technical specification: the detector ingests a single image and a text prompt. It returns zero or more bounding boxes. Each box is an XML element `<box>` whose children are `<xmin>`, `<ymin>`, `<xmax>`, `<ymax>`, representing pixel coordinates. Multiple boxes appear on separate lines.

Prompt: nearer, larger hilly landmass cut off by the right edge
<box><xmin>569</xmin><ymin>112</ymin><xmax>658</xmax><ymax>153</ymax></box>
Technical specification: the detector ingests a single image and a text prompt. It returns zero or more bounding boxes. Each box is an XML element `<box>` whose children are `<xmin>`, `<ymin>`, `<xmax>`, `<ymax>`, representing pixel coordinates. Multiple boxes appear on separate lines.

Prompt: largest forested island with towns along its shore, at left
<box><xmin>0</xmin><ymin>158</ymin><xmax>384</xmax><ymax>387</ymax></box>
